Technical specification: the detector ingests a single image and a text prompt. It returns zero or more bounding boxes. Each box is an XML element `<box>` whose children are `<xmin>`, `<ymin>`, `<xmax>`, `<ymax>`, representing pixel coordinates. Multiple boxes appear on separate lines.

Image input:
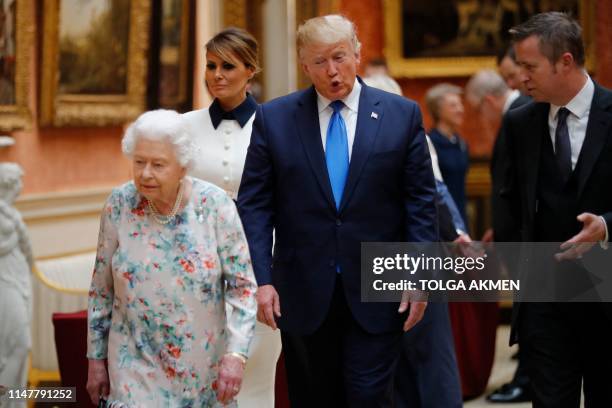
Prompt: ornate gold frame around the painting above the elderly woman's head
<box><xmin>40</xmin><ymin>0</ymin><xmax>151</xmax><ymax>127</ymax></box>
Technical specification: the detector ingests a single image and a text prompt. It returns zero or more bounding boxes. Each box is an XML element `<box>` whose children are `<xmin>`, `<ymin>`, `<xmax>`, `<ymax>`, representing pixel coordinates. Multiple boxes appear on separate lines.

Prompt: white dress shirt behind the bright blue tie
<box><xmin>317</xmin><ymin>79</ymin><xmax>361</xmax><ymax>161</ymax></box>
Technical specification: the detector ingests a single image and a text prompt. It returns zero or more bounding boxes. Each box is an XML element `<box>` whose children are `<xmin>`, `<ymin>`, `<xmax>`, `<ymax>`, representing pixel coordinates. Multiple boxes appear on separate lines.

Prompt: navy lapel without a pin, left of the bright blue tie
<box><xmin>295</xmin><ymin>87</ymin><xmax>336</xmax><ymax>211</ymax></box>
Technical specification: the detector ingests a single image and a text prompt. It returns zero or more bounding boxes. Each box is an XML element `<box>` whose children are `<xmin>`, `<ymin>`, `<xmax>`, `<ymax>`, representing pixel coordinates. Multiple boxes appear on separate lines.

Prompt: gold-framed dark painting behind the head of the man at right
<box><xmin>384</xmin><ymin>0</ymin><xmax>595</xmax><ymax>77</ymax></box>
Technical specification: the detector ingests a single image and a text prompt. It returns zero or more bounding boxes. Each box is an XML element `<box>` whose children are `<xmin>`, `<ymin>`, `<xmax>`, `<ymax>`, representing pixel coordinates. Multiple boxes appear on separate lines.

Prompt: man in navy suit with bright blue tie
<box><xmin>238</xmin><ymin>16</ymin><xmax>436</xmax><ymax>408</ymax></box>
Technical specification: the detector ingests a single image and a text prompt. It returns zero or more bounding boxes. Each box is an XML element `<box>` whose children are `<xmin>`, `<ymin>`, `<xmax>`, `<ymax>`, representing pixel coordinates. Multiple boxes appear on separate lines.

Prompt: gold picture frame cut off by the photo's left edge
<box><xmin>0</xmin><ymin>1</ymin><xmax>34</xmax><ymax>131</ymax></box>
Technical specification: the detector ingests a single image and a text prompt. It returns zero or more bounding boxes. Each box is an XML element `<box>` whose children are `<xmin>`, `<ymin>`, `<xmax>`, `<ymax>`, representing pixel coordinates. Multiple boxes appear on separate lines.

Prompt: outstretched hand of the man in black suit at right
<box><xmin>555</xmin><ymin>213</ymin><xmax>606</xmax><ymax>261</ymax></box>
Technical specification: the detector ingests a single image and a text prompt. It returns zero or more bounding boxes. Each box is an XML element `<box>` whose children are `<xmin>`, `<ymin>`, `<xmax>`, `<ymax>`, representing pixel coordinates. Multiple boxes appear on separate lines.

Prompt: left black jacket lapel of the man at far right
<box><xmin>519</xmin><ymin>103</ymin><xmax>550</xmax><ymax>219</ymax></box>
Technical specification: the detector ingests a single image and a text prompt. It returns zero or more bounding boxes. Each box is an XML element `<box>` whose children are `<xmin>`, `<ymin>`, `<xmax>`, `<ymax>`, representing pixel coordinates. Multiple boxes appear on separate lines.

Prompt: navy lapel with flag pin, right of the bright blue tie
<box><xmin>340</xmin><ymin>80</ymin><xmax>383</xmax><ymax>211</ymax></box>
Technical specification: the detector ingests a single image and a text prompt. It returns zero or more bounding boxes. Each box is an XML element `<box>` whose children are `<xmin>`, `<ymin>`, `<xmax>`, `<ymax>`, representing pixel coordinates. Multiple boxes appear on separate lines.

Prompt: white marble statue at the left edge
<box><xmin>0</xmin><ymin>163</ymin><xmax>33</xmax><ymax>400</ymax></box>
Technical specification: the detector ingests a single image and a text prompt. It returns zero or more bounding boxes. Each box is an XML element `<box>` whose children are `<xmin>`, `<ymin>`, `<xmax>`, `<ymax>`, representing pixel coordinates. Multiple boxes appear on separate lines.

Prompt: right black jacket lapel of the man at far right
<box><xmin>576</xmin><ymin>85</ymin><xmax>612</xmax><ymax>197</ymax></box>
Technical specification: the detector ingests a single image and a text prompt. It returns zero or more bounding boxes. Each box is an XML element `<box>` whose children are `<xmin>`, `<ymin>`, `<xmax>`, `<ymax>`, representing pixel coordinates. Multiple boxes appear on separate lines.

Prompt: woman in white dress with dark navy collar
<box><xmin>184</xmin><ymin>28</ymin><xmax>281</xmax><ymax>408</ymax></box>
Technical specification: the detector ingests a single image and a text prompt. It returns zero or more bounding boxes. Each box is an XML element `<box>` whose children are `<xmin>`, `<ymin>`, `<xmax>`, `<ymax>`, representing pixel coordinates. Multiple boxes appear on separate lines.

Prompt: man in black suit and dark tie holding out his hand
<box><xmin>500</xmin><ymin>12</ymin><xmax>612</xmax><ymax>407</ymax></box>
